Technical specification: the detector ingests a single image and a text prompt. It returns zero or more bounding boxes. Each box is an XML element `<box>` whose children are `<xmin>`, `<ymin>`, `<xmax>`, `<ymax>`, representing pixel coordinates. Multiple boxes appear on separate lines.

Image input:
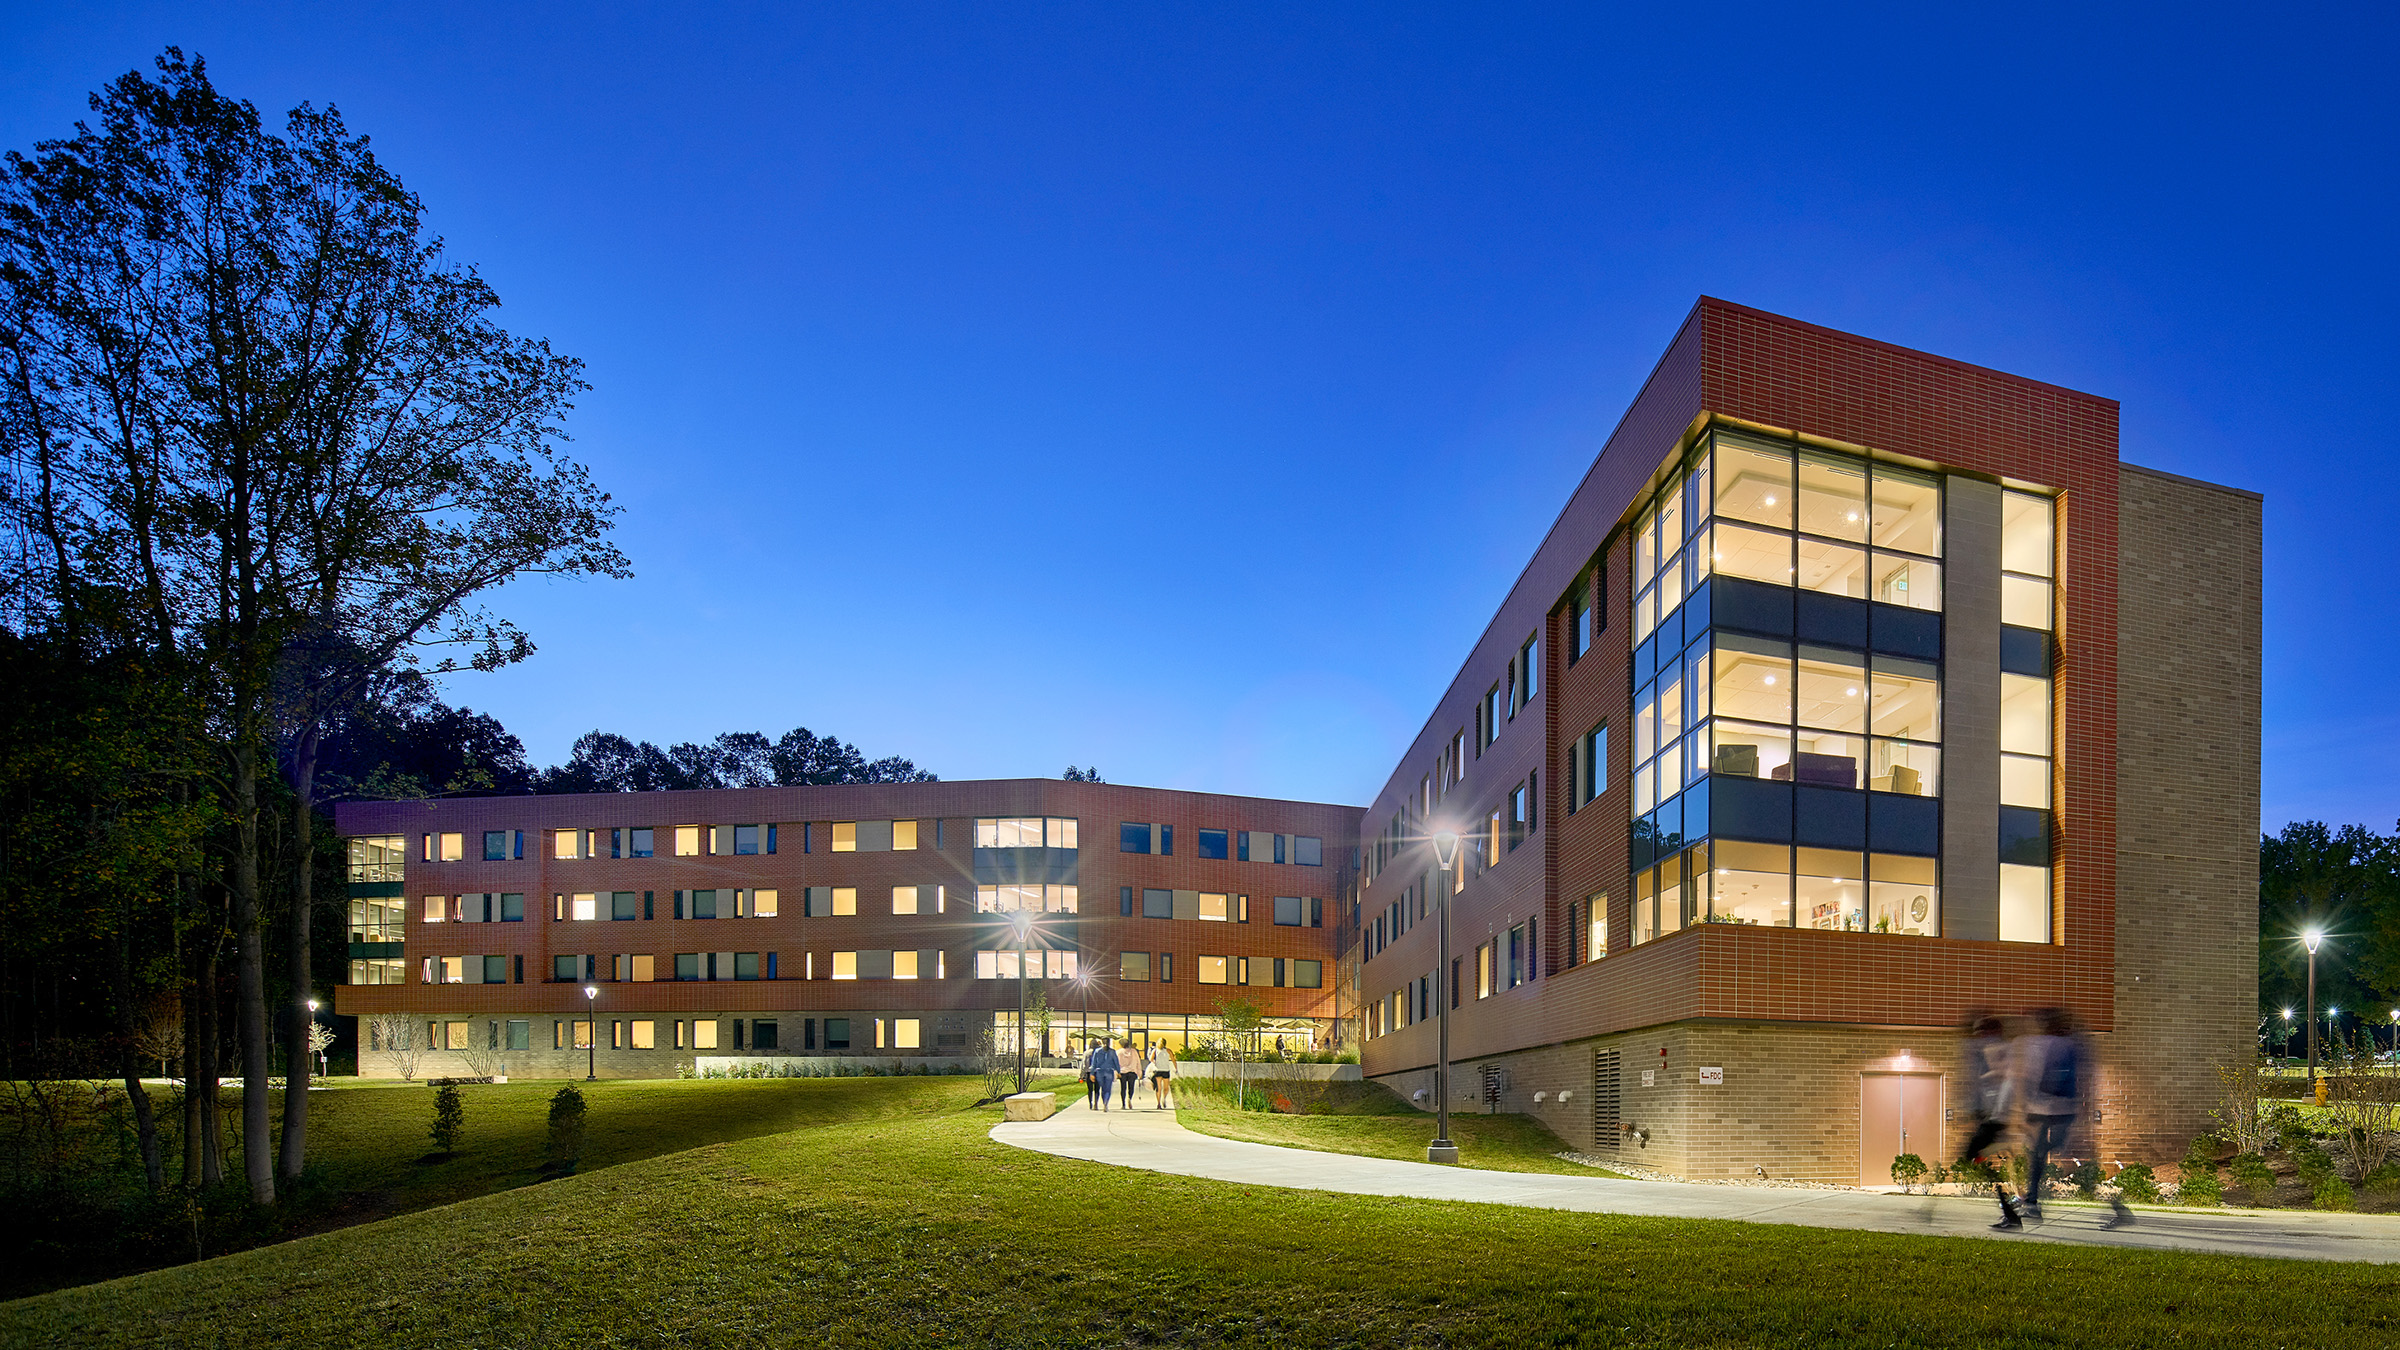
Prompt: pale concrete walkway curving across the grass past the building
<box><xmin>991</xmin><ymin>1088</ymin><xmax>2400</xmax><ymax>1261</ymax></box>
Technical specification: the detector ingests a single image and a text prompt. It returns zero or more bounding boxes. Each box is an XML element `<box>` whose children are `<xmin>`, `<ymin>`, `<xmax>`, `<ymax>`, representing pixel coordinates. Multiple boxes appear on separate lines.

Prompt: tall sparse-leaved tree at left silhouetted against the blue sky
<box><xmin>0</xmin><ymin>48</ymin><xmax>626</xmax><ymax>1201</ymax></box>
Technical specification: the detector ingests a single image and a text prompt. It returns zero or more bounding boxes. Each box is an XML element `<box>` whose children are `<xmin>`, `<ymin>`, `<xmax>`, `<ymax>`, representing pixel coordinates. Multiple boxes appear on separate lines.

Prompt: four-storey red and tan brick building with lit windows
<box><xmin>336</xmin><ymin>298</ymin><xmax>2261</xmax><ymax>1182</ymax></box>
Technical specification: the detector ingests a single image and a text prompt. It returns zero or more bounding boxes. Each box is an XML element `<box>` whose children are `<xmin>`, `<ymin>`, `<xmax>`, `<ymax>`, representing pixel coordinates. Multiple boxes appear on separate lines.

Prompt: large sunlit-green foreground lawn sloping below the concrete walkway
<box><xmin>0</xmin><ymin>1079</ymin><xmax>2400</xmax><ymax>1350</ymax></box>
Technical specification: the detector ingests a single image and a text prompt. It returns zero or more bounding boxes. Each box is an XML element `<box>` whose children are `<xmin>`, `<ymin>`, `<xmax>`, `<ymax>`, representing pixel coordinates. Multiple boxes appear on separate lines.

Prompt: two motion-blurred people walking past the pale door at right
<box><xmin>1958</xmin><ymin>1009</ymin><xmax>2134</xmax><ymax>1232</ymax></box>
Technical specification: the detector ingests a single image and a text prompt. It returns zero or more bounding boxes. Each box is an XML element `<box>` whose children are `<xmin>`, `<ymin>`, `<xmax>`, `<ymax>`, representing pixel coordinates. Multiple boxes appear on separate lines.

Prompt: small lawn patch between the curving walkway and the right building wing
<box><xmin>1171</xmin><ymin>1081</ymin><xmax>1618</xmax><ymax>1177</ymax></box>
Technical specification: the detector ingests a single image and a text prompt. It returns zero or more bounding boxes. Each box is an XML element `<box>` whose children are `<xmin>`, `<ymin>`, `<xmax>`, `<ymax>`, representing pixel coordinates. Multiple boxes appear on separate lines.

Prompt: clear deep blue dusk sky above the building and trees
<box><xmin>0</xmin><ymin>2</ymin><xmax>2400</xmax><ymax>829</ymax></box>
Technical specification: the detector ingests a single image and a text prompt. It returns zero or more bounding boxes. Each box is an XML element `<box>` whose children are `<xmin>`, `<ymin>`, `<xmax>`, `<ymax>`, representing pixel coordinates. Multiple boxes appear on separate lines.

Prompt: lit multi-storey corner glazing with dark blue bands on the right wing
<box><xmin>1630</xmin><ymin>428</ymin><xmax>1942</xmax><ymax>944</ymax></box>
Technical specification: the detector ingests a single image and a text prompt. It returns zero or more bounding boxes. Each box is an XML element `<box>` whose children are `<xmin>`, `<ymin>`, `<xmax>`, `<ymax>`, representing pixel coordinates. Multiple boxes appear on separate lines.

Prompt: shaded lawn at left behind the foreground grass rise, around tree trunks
<box><xmin>0</xmin><ymin>1079</ymin><xmax>962</xmax><ymax>1297</ymax></box>
